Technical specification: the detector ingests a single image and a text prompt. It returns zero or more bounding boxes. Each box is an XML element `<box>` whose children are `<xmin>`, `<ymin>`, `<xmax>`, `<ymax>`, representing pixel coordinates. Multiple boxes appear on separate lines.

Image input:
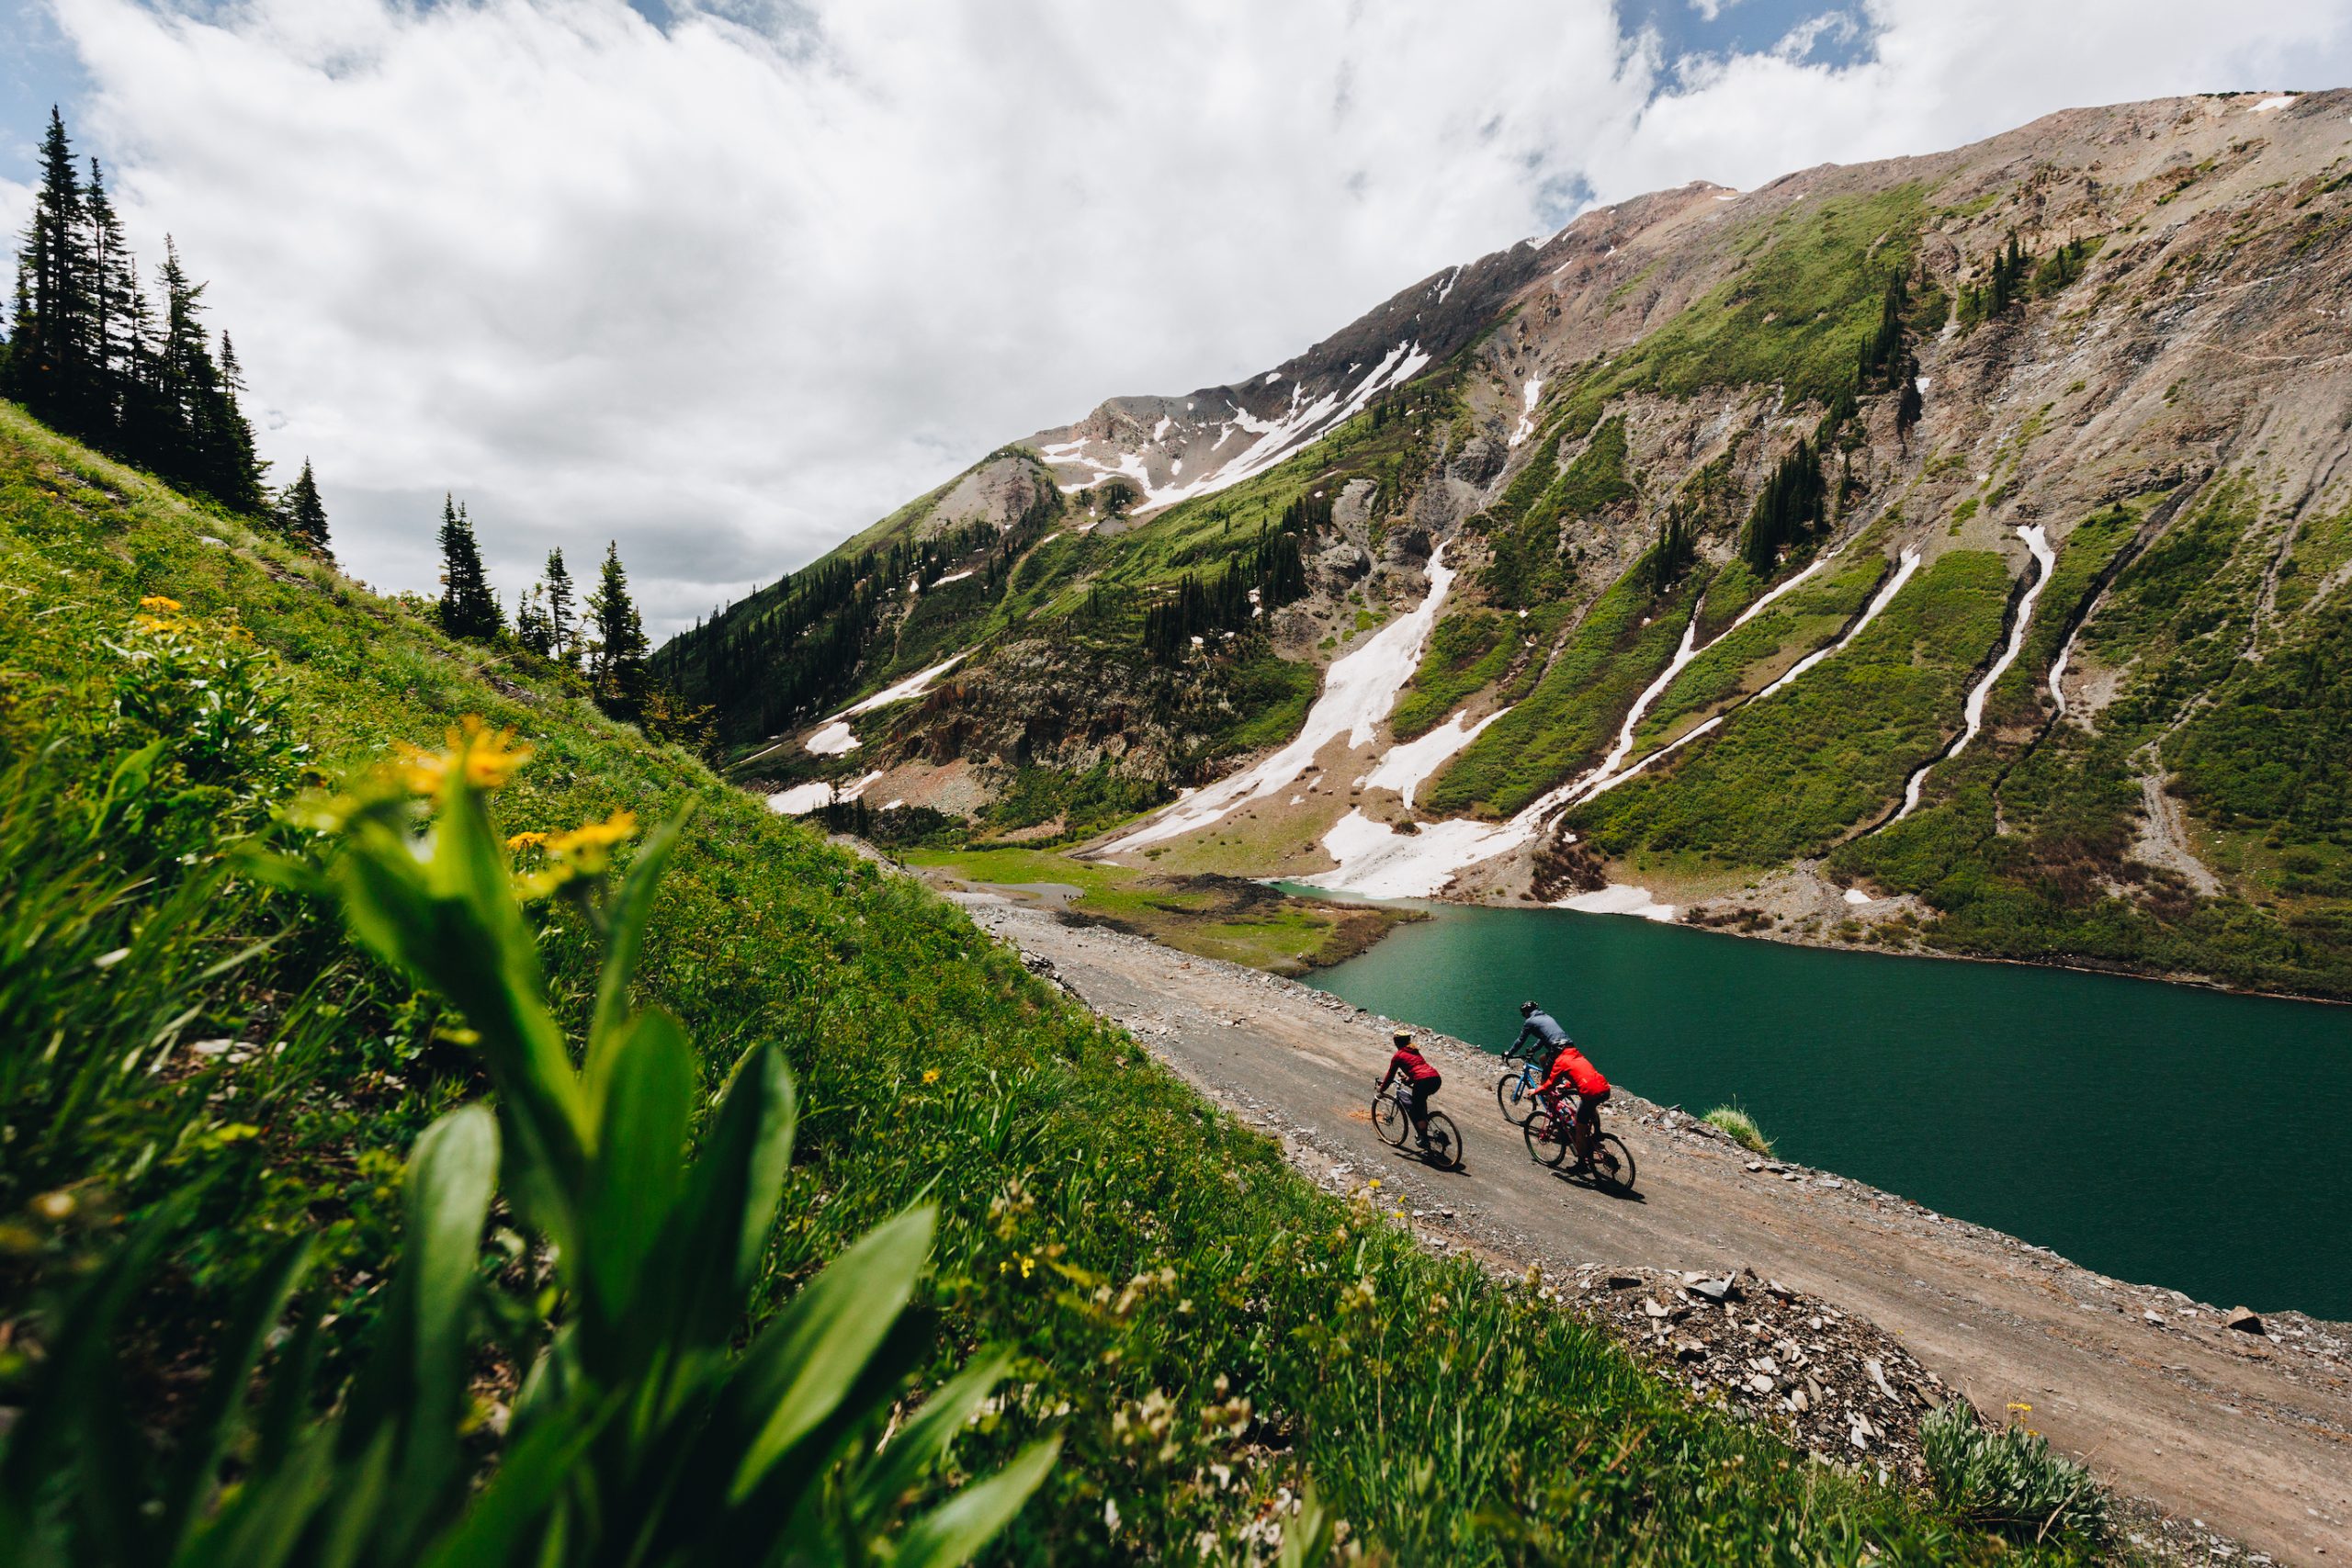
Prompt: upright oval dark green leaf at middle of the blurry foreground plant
<box><xmin>581</xmin><ymin>1010</ymin><xmax>694</xmax><ymax>1324</ymax></box>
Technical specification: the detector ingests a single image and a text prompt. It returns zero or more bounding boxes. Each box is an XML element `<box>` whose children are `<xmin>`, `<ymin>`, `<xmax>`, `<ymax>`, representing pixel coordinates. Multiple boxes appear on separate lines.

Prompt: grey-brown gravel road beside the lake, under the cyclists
<box><xmin>959</xmin><ymin>894</ymin><xmax>2352</xmax><ymax>1565</ymax></box>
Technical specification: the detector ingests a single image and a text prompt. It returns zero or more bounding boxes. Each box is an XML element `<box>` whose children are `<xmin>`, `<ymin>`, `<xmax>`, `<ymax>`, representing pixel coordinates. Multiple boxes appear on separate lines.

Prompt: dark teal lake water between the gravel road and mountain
<box><xmin>1301</xmin><ymin>888</ymin><xmax>2352</xmax><ymax>1319</ymax></box>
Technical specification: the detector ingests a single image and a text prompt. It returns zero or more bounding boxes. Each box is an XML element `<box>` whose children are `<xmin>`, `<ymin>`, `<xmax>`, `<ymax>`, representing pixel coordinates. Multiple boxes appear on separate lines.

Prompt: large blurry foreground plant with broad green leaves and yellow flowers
<box><xmin>0</xmin><ymin>728</ymin><xmax>1056</xmax><ymax>1568</ymax></box>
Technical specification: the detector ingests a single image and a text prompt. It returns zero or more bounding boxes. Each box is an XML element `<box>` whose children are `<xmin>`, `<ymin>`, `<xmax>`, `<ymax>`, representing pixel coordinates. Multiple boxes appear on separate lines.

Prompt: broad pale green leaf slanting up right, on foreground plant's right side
<box><xmin>727</xmin><ymin>1206</ymin><xmax>938</xmax><ymax>1502</ymax></box>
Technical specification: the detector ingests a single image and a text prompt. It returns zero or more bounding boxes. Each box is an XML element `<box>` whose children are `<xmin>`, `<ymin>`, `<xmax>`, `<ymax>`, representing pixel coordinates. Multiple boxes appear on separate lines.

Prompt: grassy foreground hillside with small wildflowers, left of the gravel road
<box><xmin>0</xmin><ymin>404</ymin><xmax>2063</xmax><ymax>1563</ymax></box>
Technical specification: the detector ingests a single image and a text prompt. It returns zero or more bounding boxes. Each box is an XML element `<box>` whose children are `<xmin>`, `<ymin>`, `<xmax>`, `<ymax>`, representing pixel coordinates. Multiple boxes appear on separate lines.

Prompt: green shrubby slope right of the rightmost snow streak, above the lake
<box><xmin>1830</xmin><ymin>478</ymin><xmax>2352</xmax><ymax>997</ymax></box>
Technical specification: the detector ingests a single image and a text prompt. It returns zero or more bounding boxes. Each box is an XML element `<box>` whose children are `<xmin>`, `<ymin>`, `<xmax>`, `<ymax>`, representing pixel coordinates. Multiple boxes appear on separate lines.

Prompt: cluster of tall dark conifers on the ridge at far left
<box><xmin>0</xmin><ymin>108</ymin><xmax>327</xmax><ymax>543</ymax></box>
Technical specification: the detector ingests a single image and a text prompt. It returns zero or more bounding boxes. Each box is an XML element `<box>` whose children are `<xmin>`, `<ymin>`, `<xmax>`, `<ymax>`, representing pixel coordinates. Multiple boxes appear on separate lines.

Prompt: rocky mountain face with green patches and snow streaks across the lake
<box><xmin>663</xmin><ymin>92</ymin><xmax>2352</xmax><ymax>995</ymax></box>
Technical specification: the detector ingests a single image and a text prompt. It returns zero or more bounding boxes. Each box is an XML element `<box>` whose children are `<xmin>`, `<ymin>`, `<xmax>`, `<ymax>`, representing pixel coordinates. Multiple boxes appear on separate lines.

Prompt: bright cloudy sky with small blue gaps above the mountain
<box><xmin>0</xmin><ymin>0</ymin><xmax>2352</xmax><ymax>630</ymax></box>
